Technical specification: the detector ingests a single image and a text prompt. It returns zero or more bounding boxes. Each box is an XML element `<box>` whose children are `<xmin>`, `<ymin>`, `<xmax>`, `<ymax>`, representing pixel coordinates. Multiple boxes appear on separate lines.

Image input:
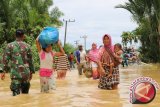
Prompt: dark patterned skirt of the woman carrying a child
<box><xmin>98</xmin><ymin>67</ymin><xmax>119</xmax><ymax>90</ymax></box>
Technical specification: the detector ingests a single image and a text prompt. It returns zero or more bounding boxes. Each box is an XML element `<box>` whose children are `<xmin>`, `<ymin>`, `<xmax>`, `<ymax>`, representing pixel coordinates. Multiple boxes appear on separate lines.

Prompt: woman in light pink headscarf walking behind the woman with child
<box><xmin>88</xmin><ymin>43</ymin><xmax>99</xmax><ymax>79</ymax></box>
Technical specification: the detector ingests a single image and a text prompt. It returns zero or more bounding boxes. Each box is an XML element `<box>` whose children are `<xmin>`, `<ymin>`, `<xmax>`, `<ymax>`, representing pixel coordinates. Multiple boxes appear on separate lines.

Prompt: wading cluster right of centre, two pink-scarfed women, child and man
<box><xmin>75</xmin><ymin>34</ymin><xmax>123</xmax><ymax>90</ymax></box>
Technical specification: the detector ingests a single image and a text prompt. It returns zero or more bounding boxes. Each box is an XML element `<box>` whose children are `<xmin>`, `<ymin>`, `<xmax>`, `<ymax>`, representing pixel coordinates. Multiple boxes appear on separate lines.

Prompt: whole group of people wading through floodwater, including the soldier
<box><xmin>1</xmin><ymin>29</ymin><xmax>122</xmax><ymax>96</ymax></box>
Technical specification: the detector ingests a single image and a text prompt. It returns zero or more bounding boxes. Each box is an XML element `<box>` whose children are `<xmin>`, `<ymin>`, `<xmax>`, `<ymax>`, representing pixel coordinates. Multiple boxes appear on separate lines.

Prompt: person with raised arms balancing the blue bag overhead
<box><xmin>36</xmin><ymin>36</ymin><xmax>65</xmax><ymax>93</ymax></box>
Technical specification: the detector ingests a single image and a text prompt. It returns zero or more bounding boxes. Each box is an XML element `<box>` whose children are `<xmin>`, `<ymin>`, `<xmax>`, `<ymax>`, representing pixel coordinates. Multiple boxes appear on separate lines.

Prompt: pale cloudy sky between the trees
<box><xmin>50</xmin><ymin>0</ymin><xmax>137</xmax><ymax>49</ymax></box>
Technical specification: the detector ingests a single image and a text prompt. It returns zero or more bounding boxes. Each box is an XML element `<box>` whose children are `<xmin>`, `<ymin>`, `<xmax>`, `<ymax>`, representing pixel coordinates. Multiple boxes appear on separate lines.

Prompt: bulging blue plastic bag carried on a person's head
<box><xmin>39</xmin><ymin>27</ymin><xmax>59</xmax><ymax>48</ymax></box>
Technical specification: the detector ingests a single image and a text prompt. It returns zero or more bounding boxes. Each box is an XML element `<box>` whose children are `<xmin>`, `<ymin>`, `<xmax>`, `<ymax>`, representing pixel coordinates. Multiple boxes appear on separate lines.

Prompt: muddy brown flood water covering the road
<box><xmin>0</xmin><ymin>64</ymin><xmax>160</xmax><ymax>107</ymax></box>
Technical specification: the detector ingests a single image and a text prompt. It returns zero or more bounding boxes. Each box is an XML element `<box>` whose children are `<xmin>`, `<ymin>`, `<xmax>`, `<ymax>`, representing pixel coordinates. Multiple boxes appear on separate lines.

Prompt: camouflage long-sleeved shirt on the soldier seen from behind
<box><xmin>3</xmin><ymin>41</ymin><xmax>35</xmax><ymax>80</ymax></box>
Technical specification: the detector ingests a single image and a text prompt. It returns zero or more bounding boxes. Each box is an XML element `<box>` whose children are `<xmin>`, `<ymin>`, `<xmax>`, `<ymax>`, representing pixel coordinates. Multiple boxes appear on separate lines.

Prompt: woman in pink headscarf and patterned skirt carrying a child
<box><xmin>98</xmin><ymin>34</ymin><xmax>119</xmax><ymax>90</ymax></box>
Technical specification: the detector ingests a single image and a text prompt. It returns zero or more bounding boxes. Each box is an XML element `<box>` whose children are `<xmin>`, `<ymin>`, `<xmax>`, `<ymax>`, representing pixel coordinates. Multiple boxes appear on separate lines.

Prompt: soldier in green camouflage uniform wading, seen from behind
<box><xmin>1</xmin><ymin>29</ymin><xmax>35</xmax><ymax>96</ymax></box>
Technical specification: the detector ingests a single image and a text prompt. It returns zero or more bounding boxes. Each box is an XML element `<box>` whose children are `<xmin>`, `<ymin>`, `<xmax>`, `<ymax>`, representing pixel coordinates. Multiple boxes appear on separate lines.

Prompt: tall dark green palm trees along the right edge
<box><xmin>116</xmin><ymin>0</ymin><xmax>160</xmax><ymax>62</ymax></box>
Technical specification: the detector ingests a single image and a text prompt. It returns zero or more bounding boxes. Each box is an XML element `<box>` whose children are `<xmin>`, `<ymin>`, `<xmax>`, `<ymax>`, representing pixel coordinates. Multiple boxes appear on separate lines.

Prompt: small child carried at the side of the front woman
<box><xmin>114</xmin><ymin>43</ymin><xmax>123</xmax><ymax>63</ymax></box>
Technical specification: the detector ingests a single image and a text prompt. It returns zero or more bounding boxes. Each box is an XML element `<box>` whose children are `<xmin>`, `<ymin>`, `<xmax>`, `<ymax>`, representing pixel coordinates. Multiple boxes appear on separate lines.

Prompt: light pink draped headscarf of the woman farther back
<box><xmin>88</xmin><ymin>43</ymin><xmax>99</xmax><ymax>61</ymax></box>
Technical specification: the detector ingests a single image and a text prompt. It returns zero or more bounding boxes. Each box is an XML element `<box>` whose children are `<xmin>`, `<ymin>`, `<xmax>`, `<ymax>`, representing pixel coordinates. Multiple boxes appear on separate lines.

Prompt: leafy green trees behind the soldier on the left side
<box><xmin>0</xmin><ymin>0</ymin><xmax>63</xmax><ymax>70</ymax></box>
